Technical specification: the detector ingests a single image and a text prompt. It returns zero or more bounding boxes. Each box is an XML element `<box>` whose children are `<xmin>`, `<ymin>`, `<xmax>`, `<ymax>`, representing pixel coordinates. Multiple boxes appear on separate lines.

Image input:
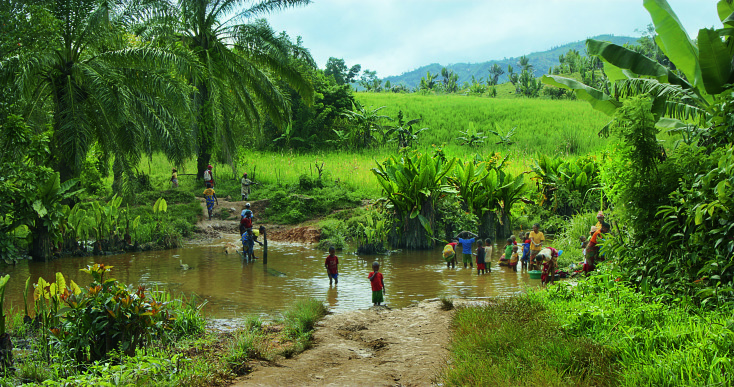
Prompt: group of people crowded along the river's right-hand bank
<box><xmin>443</xmin><ymin>211</ymin><xmax>610</xmax><ymax>285</ymax></box>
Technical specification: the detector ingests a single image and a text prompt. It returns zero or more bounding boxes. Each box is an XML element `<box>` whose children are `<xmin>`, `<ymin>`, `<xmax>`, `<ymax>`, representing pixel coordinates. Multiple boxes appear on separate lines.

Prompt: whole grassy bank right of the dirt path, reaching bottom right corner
<box><xmin>443</xmin><ymin>275</ymin><xmax>734</xmax><ymax>386</ymax></box>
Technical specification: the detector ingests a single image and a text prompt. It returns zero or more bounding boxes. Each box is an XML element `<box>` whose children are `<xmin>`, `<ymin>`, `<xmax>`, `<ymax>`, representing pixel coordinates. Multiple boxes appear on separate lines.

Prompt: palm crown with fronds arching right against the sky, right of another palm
<box><xmin>171</xmin><ymin>0</ymin><xmax>313</xmax><ymax>176</ymax></box>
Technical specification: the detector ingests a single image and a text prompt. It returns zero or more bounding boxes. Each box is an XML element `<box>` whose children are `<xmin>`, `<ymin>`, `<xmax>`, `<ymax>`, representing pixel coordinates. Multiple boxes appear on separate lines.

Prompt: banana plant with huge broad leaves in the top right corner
<box><xmin>543</xmin><ymin>0</ymin><xmax>734</xmax><ymax>135</ymax></box>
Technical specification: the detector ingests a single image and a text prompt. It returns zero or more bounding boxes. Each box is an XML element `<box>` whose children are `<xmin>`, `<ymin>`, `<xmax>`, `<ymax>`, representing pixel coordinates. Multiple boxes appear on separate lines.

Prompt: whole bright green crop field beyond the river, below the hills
<box><xmin>135</xmin><ymin>93</ymin><xmax>620</xmax><ymax>197</ymax></box>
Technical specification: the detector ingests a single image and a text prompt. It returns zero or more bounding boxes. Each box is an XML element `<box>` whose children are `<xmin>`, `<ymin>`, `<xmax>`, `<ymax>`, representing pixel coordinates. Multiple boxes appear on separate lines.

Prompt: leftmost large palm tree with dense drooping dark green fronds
<box><xmin>0</xmin><ymin>0</ymin><xmax>196</xmax><ymax>188</ymax></box>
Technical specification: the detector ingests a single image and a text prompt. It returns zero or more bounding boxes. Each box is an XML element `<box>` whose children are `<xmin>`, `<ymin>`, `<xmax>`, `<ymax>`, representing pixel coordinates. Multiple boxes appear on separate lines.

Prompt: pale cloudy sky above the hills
<box><xmin>268</xmin><ymin>0</ymin><xmax>721</xmax><ymax>77</ymax></box>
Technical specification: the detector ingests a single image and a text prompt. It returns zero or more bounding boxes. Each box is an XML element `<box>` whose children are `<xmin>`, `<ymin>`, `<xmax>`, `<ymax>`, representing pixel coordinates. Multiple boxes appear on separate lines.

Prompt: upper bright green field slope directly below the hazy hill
<box><xmin>356</xmin><ymin>93</ymin><xmax>609</xmax><ymax>159</ymax></box>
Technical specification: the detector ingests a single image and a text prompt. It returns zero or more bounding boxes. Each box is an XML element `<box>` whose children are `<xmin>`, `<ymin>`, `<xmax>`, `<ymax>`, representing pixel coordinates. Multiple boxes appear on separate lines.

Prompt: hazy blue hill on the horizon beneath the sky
<box><xmin>383</xmin><ymin>35</ymin><xmax>638</xmax><ymax>88</ymax></box>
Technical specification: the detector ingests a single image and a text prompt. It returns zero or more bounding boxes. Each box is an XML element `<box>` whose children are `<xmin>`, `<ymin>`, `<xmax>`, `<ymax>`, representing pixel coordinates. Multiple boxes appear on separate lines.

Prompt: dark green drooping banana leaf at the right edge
<box><xmin>698</xmin><ymin>28</ymin><xmax>732</xmax><ymax>94</ymax></box>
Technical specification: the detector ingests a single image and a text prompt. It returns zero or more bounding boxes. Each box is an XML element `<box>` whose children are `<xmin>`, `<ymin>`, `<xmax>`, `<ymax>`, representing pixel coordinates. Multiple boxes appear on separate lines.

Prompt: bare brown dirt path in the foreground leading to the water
<box><xmin>233</xmin><ymin>301</ymin><xmax>451</xmax><ymax>386</ymax></box>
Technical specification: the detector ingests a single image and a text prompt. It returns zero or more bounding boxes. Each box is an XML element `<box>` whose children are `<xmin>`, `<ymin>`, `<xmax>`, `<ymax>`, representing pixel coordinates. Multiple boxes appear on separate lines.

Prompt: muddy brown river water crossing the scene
<box><xmin>4</xmin><ymin>236</ymin><xmax>540</xmax><ymax>319</ymax></box>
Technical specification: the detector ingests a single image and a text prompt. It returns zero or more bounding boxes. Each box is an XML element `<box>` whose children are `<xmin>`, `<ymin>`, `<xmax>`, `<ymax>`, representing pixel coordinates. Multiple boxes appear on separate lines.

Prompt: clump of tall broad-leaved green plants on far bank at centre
<box><xmin>373</xmin><ymin>152</ymin><xmax>527</xmax><ymax>248</ymax></box>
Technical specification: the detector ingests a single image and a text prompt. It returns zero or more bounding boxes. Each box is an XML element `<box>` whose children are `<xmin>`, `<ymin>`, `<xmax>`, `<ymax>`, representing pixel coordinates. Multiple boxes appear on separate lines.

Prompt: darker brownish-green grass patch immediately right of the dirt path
<box><xmin>442</xmin><ymin>297</ymin><xmax>618</xmax><ymax>386</ymax></box>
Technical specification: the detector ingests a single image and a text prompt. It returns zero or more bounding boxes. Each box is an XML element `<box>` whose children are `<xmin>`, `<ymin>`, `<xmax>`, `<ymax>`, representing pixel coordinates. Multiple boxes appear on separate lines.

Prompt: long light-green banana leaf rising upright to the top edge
<box><xmin>643</xmin><ymin>0</ymin><xmax>703</xmax><ymax>87</ymax></box>
